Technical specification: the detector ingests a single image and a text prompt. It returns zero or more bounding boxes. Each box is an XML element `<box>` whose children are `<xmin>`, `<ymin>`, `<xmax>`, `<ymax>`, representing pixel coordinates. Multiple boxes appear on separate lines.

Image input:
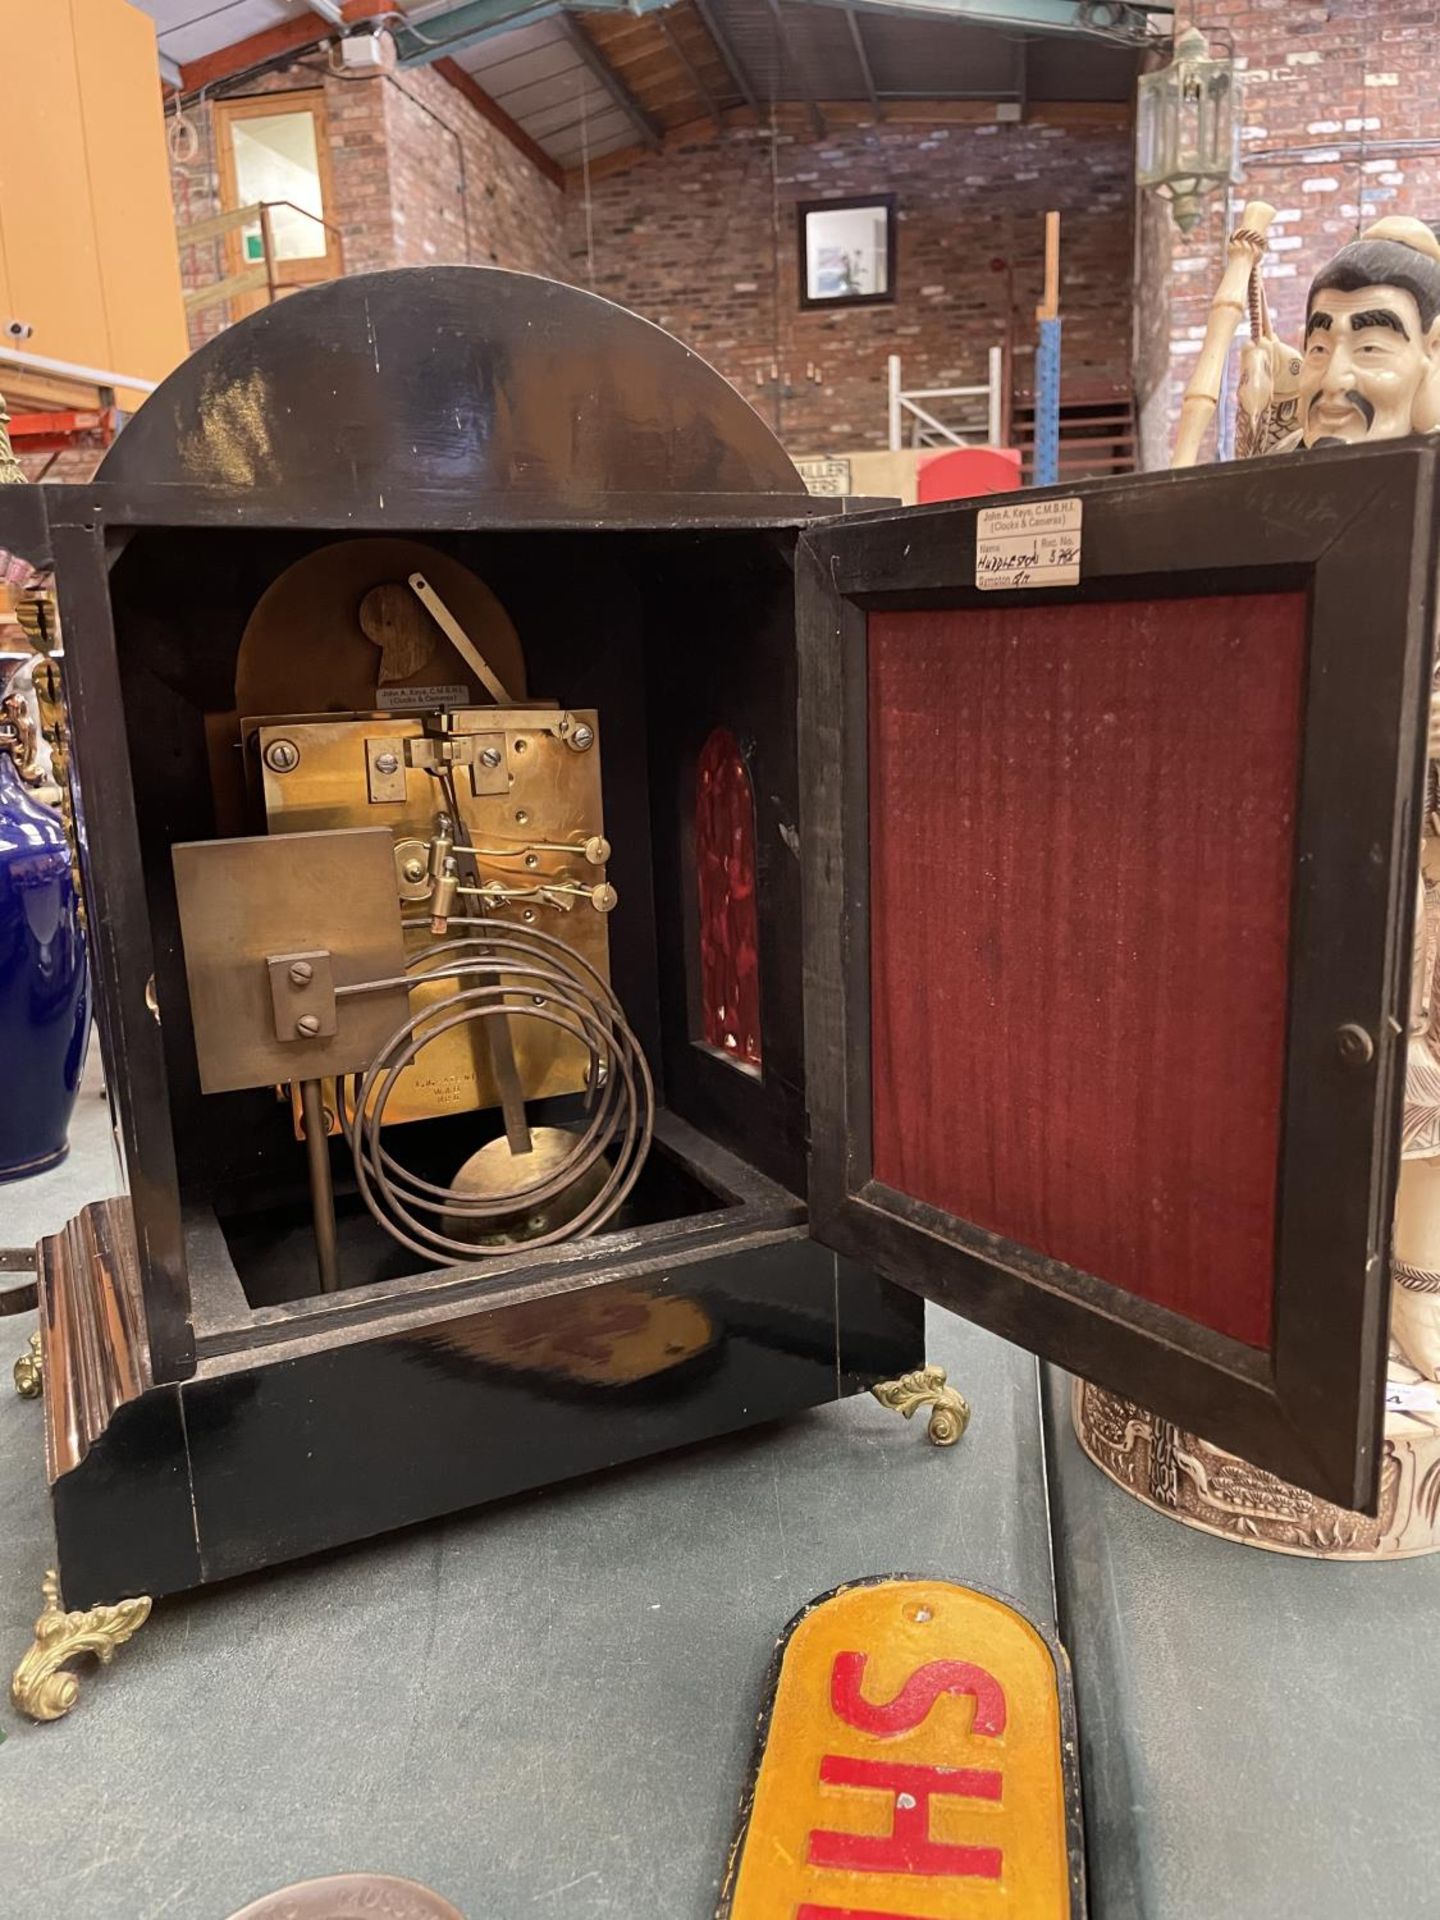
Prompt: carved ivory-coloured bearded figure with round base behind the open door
<box><xmin>1075</xmin><ymin>214</ymin><xmax>1440</xmax><ymax>1559</ymax></box>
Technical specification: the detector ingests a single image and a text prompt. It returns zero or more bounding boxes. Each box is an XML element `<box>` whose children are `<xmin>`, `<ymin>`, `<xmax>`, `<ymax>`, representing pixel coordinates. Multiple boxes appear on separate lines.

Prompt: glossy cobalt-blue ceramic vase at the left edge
<box><xmin>0</xmin><ymin>743</ymin><xmax>90</xmax><ymax>1175</ymax></box>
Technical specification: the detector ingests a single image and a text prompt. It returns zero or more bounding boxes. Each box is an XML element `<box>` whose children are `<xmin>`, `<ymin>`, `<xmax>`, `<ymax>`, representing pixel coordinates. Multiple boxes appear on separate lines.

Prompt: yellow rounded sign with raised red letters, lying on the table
<box><xmin>720</xmin><ymin>1578</ymin><xmax>1085</xmax><ymax>1920</ymax></box>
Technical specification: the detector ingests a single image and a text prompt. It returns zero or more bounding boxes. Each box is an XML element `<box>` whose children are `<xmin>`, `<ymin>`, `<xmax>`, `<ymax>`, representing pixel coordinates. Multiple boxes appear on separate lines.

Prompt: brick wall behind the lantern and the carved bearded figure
<box><xmin>1142</xmin><ymin>0</ymin><xmax>1440</xmax><ymax>457</ymax></box>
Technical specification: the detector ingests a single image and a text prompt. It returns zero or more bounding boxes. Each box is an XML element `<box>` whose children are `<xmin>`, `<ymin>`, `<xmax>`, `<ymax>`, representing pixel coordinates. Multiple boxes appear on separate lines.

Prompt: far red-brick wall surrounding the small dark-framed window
<box><xmin>566</xmin><ymin>109</ymin><xmax>1133</xmax><ymax>451</ymax></box>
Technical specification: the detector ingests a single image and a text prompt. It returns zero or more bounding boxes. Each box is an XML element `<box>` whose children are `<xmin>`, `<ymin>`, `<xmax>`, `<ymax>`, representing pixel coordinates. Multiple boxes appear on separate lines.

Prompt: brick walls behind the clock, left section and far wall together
<box><xmin>53</xmin><ymin>58</ymin><xmax>1135</xmax><ymax>476</ymax></box>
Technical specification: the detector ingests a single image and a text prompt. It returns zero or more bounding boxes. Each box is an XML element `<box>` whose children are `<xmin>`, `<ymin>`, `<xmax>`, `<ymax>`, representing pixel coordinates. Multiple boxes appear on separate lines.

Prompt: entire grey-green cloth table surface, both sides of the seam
<box><xmin>0</xmin><ymin>1075</ymin><xmax>1440</xmax><ymax>1920</ymax></box>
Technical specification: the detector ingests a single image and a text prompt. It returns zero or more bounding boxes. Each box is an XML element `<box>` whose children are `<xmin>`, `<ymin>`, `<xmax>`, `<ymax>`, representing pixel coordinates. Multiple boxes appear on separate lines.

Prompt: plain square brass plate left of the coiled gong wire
<box><xmin>171</xmin><ymin>829</ymin><xmax>409</xmax><ymax>1092</ymax></box>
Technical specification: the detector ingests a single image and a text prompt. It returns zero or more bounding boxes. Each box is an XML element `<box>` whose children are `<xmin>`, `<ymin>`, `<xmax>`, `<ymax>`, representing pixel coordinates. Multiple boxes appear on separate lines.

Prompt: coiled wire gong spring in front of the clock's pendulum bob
<box><xmin>340</xmin><ymin>918</ymin><xmax>655</xmax><ymax>1265</ymax></box>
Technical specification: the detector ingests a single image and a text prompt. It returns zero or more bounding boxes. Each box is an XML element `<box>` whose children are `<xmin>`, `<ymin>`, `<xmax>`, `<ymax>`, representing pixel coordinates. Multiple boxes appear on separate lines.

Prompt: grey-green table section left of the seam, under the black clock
<box><xmin>0</xmin><ymin>1075</ymin><xmax>1052</xmax><ymax>1920</ymax></box>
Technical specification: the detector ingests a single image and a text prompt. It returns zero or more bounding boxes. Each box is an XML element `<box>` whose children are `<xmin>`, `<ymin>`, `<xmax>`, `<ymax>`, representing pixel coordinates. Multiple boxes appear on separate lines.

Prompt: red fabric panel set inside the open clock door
<box><xmin>870</xmin><ymin>593</ymin><xmax>1306</xmax><ymax>1346</ymax></box>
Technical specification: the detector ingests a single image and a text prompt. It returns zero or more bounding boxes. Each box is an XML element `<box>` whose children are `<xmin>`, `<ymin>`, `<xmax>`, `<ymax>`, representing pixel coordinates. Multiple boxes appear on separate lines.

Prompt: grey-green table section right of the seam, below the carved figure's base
<box><xmin>1046</xmin><ymin>1373</ymin><xmax>1440</xmax><ymax>1920</ymax></box>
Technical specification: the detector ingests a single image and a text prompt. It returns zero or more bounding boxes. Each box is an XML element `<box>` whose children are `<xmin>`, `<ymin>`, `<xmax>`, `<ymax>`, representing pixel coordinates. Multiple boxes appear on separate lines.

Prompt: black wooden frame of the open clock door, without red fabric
<box><xmin>797</xmin><ymin>444</ymin><xmax>1440</xmax><ymax>1513</ymax></box>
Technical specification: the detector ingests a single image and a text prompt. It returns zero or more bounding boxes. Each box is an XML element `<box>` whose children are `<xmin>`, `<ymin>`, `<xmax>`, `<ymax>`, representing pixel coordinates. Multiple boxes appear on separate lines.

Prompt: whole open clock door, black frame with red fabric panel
<box><xmin>799</xmin><ymin>444</ymin><xmax>1436</xmax><ymax>1511</ymax></box>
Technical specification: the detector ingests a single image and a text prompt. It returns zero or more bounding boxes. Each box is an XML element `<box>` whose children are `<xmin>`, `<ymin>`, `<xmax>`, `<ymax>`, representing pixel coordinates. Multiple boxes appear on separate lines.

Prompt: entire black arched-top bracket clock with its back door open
<box><xmin>0</xmin><ymin>267</ymin><xmax>1436</xmax><ymax>1712</ymax></box>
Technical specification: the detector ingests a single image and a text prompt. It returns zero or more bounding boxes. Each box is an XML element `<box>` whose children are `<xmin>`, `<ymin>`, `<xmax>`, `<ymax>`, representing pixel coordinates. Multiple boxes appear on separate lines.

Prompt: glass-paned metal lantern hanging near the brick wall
<box><xmin>1135</xmin><ymin>27</ymin><xmax>1240</xmax><ymax>234</ymax></box>
